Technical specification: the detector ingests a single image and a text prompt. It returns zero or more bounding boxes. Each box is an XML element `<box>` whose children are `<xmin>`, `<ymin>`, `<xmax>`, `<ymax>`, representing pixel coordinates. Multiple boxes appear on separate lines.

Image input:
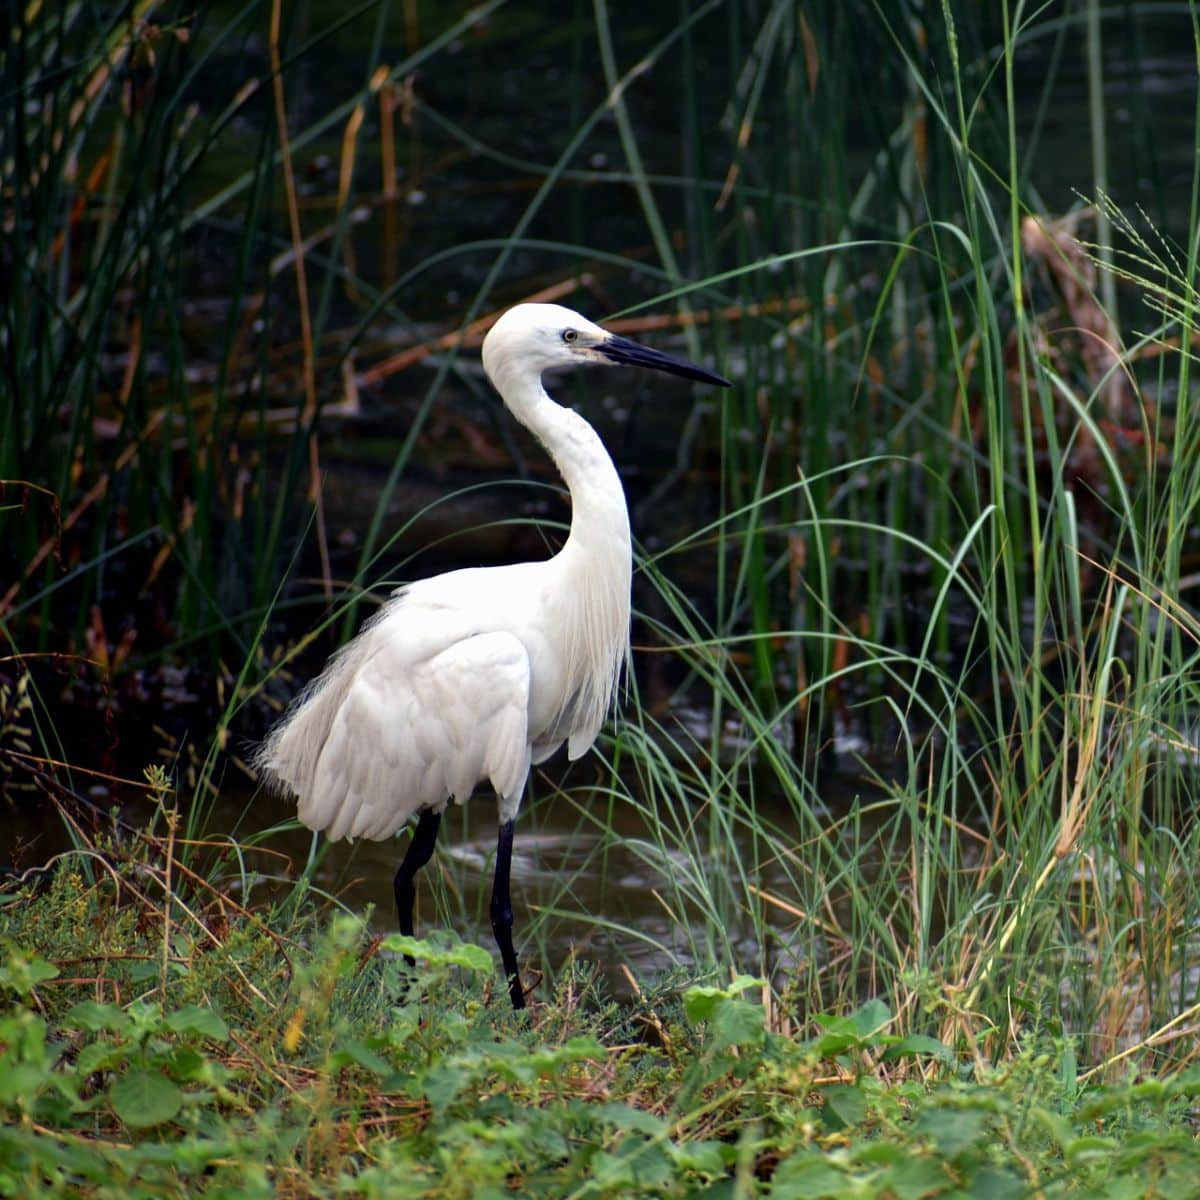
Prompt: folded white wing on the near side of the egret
<box><xmin>300</xmin><ymin>625</ymin><xmax>529</xmax><ymax>840</ymax></box>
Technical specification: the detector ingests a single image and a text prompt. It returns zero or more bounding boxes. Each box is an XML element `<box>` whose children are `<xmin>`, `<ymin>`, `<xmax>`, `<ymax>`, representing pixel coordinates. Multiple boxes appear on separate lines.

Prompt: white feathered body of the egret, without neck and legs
<box><xmin>258</xmin><ymin>554</ymin><xmax>628</xmax><ymax>839</ymax></box>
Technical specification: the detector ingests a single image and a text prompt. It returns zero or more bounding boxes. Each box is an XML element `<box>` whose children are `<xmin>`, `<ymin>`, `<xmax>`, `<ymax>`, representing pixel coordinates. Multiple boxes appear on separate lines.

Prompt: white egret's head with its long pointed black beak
<box><xmin>482</xmin><ymin>304</ymin><xmax>732</xmax><ymax>391</ymax></box>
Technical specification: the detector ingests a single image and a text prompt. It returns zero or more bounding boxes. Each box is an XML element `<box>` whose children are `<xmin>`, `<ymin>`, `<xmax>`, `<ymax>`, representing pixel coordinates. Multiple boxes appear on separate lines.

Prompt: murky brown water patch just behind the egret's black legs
<box><xmin>210</xmin><ymin>756</ymin><xmax>872</xmax><ymax>998</ymax></box>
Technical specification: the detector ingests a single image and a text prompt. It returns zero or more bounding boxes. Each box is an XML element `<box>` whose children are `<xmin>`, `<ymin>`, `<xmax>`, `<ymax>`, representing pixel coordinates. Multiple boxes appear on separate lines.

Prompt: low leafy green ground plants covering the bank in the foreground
<box><xmin>0</xmin><ymin>839</ymin><xmax>1200</xmax><ymax>1200</ymax></box>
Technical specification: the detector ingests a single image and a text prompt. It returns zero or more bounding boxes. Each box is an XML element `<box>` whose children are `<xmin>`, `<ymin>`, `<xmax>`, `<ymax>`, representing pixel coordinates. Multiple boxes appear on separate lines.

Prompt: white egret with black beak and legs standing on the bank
<box><xmin>256</xmin><ymin>304</ymin><xmax>731</xmax><ymax>1009</ymax></box>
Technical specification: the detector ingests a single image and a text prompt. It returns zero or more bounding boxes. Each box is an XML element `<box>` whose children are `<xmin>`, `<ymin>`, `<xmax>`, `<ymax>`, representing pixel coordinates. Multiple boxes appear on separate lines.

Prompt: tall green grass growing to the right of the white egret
<box><xmin>465</xmin><ymin>6</ymin><xmax>1200</xmax><ymax>1069</ymax></box>
